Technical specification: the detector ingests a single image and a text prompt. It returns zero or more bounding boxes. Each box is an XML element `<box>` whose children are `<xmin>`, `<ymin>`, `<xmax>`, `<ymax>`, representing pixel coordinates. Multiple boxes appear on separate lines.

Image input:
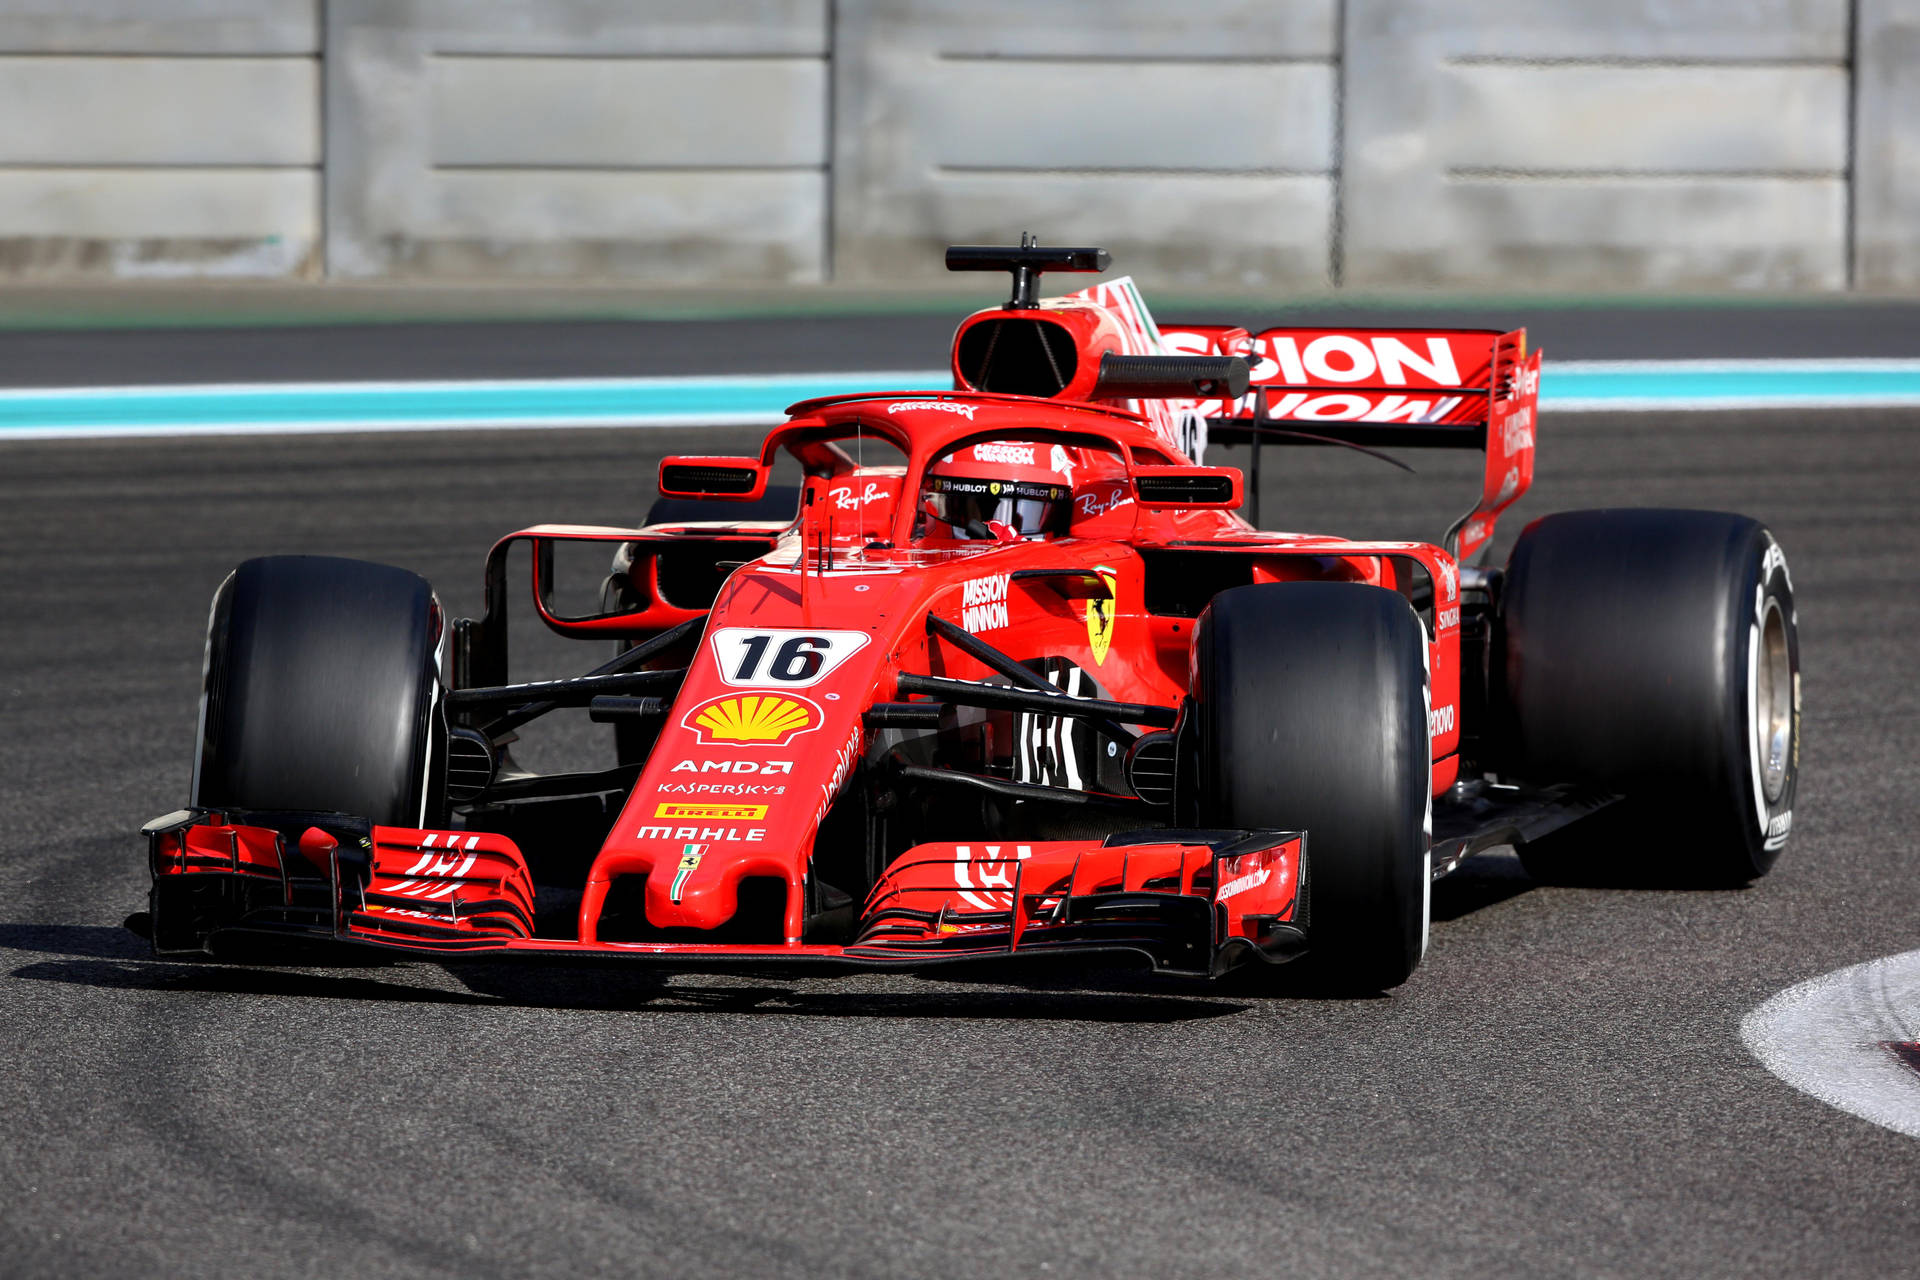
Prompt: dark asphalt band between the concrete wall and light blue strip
<box><xmin>11</xmin><ymin>297</ymin><xmax>1920</xmax><ymax>386</ymax></box>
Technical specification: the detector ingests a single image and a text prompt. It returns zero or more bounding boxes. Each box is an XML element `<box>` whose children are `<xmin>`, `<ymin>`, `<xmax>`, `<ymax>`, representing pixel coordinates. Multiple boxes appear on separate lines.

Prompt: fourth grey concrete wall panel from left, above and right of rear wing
<box><xmin>1342</xmin><ymin>0</ymin><xmax>1849</xmax><ymax>288</ymax></box>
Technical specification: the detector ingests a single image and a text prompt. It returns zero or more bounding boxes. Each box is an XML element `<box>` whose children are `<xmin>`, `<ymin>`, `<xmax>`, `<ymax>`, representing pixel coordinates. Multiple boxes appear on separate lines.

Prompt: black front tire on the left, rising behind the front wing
<box><xmin>192</xmin><ymin>557</ymin><xmax>442</xmax><ymax>827</ymax></box>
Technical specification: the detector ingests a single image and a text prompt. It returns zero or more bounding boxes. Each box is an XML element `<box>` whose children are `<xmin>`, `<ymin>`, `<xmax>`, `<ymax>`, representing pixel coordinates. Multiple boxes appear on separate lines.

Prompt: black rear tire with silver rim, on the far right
<box><xmin>1494</xmin><ymin>509</ymin><xmax>1799</xmax><ymax>887</ymax></box>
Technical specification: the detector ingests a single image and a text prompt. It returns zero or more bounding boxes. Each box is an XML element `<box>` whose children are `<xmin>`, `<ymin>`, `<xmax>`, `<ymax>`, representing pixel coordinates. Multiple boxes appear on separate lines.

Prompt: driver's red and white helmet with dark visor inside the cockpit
<box><xmin>920</xmin><ymin>439</ymin><xmax>1075</xmax><ymax>541</ymax></box>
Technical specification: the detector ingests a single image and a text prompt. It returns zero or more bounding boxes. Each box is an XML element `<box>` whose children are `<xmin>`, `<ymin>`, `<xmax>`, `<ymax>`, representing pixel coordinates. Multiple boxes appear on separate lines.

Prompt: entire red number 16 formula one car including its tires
<box><xmin>131</xmin><ymin>246</ymin><xmax>1799</xmax><ymax>990</ymax></box>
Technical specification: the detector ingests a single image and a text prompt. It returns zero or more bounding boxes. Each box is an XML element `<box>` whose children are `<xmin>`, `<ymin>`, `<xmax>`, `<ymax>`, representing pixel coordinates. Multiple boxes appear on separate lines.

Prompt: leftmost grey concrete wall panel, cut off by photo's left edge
<box><xmin>0</xmin><ymin>0</ymin><xmax>323</xmax><ymax>280</ymax></box>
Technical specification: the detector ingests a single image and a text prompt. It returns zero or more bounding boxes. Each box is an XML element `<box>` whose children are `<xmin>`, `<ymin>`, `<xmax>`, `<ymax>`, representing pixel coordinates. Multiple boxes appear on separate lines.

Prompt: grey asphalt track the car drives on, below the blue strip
<box><xmin>0</xmin><ymin>322</ymin><xmax>1920</xmax><ymax>1278</ymax></box>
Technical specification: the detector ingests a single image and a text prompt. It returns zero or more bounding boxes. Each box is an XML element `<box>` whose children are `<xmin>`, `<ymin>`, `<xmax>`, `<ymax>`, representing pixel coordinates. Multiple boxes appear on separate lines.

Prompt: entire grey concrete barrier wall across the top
<box><xmin>0</xmin><ymin>0</ymin><xmax>1920</xmax><ymax>290</ymax></box>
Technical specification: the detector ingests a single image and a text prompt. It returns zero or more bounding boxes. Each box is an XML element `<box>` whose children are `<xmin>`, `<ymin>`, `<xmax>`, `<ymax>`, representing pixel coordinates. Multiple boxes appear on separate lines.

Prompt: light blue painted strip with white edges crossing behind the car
<box><xmin>0</xmin><ymin>359</ymin><xmax>1920</xmax><ymax>439</ymax></box>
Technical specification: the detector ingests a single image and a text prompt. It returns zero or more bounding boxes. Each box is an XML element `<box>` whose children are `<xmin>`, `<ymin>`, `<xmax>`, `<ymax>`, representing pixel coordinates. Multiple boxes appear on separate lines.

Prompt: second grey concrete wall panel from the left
<box><xmin>324</xmin><ymin>0</ymin><xmax>828</xmax><ymax>284</ymax></box>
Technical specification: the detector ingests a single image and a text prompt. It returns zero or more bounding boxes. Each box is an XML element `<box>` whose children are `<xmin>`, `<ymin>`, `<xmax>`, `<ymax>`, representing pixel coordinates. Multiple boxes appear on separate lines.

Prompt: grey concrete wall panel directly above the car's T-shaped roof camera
<box><xmin>833</xmin><ymin>0</ymin><xmax>1338</xmax><ymax>286</ymax></box>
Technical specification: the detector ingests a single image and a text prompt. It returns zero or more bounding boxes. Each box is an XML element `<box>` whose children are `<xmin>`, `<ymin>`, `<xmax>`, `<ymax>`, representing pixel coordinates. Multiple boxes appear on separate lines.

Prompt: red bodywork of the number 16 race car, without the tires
<box><xmin>152</xmin><ymin>270</ymin><xmax>1540</xmax><ymax>973</ymax></box>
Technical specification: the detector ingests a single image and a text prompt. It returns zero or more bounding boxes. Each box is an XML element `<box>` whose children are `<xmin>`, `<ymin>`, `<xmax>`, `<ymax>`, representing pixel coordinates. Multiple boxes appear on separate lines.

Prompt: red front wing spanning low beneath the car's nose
<box><xmin>144</xmin><ymin>810</ymin><xmax>1308</xmax><ymax>977</ymax></box>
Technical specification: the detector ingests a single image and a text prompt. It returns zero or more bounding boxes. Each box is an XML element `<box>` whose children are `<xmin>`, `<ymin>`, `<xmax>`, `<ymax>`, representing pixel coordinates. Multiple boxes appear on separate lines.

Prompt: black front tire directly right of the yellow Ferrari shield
<box><xmin>1190</xmin><ymin>583</ymin><xmax>1432</xmax><ymax>992</ymax></box>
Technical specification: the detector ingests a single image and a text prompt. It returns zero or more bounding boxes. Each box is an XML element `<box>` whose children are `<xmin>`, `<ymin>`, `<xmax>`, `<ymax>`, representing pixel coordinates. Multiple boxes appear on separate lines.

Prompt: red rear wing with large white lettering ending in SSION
<box><xmin>1160</xmin><ymin>324</ymin><xmax>1540</xmax><ymax>562</ymax></box>
